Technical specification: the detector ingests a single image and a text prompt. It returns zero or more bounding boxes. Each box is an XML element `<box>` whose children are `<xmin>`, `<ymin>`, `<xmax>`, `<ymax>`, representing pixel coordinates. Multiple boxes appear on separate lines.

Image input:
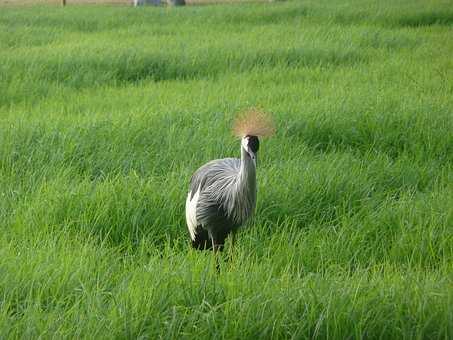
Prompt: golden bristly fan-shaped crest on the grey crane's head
<box><xmin>233</xmin><ymin>108</ymin><xmax>275</xmax><ymax>138</ymax></box>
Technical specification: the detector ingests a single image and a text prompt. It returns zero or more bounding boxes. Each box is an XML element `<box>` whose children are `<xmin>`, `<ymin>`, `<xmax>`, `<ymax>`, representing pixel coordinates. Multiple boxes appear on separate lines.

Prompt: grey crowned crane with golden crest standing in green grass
<box><xmin>186</xmin><ymin>108</ymin><xmax>274</xmax><ymax>252</ymax></box>
